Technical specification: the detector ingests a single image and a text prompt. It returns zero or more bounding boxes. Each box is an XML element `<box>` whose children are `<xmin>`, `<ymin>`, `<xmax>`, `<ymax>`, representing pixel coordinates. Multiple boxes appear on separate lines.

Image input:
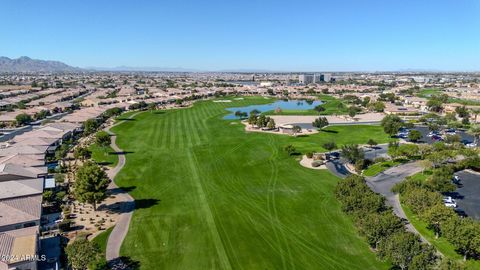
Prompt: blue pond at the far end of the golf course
<box><xmin>223</xmin><ymin>100</ymin><xmax>323</xmax><ymax>120</ymax></box>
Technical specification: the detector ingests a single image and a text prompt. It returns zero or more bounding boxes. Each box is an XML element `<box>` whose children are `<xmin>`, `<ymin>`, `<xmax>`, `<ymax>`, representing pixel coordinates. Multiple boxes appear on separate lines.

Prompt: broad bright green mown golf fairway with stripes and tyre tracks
<box><xmin>113</xmin><ymin>97</ymin><xmax>389</xmax><ymax>270</ymax></box>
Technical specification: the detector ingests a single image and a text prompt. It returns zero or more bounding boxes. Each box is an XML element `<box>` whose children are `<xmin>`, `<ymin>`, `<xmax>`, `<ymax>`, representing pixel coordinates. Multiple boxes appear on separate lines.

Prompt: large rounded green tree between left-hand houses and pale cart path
<box><xmin>74</xmin><ymin>161</ymin><xmax>110</xmax><ymax>211</ymax></box>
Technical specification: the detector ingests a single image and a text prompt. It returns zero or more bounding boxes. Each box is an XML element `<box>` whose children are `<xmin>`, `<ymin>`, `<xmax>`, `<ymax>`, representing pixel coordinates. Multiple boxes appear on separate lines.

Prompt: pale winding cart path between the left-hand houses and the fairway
<box><xmin>104</xmin><ymin>112</ymin><xmax>140</xmax><ymax>269</ymax></box>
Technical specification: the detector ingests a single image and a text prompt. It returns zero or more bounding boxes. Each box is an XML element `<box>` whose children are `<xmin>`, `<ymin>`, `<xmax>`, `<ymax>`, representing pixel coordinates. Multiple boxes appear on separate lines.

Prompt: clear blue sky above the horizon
<box><xmin>0</xmin><ymin>0</ymin><xmax>480</xmax><ymax>71</ymax></box>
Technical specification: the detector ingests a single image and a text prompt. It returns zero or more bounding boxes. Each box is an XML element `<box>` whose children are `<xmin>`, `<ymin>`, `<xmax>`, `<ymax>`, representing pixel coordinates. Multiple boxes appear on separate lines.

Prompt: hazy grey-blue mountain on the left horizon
<box><xmin>0</xmin><ymin>56</ymin><xmax>84</xmax><ymax>73</ymax></box>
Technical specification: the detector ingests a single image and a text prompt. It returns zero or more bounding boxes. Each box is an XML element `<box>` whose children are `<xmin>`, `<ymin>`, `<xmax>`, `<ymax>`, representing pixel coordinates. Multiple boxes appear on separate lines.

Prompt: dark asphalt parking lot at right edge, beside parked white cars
<box><xmin>452</xmin><ymin>171</ymin><xmax>480</xmax><ymax>220</ymax></box>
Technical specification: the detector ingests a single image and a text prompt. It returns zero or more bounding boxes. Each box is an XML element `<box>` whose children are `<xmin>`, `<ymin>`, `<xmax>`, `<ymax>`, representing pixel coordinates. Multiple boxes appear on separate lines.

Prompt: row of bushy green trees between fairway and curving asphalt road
<box><xmin>335</xmin><ymin>175</ymin><xmax>438</xmax><ymax>269</ymax></box>
